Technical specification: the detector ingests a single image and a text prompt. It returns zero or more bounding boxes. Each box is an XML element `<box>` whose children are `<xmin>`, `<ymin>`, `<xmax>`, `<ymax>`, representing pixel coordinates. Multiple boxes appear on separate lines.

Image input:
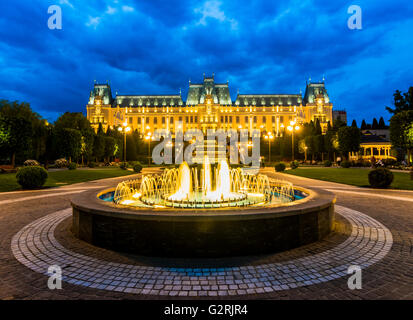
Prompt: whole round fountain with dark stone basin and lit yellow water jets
<box><xmin>72</xmin><ymin>158</ymin><xmax>335</xmax><ymax>257</ymax></box>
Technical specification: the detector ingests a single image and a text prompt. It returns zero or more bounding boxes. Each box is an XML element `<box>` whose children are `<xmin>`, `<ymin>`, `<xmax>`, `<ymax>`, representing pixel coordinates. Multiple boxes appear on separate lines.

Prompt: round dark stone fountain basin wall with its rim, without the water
<box><xmin>72</xmin><ymin>187</ymin><xmax>335</xmax><ymax>257</ymax></box>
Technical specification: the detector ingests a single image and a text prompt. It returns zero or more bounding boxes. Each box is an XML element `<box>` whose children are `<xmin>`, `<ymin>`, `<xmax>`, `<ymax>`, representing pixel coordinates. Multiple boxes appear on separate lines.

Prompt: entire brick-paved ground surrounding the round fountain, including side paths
<box><xmin>0</xmin><ymin>171</ymin><xmax>413</xmax><ymax>299</ymax></box>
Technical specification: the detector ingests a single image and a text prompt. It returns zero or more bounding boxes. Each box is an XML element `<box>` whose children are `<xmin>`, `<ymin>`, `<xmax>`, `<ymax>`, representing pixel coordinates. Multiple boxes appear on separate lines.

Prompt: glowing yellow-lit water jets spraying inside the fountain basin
<box><xmin>113</xmin><ymin>157</ymin><xmax>294</xmax><ymax>209</ymax></box>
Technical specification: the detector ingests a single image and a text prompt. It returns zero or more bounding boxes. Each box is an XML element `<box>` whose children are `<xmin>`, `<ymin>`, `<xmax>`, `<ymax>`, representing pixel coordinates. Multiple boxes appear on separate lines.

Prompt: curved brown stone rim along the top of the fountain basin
<box><xmin>71</xmin><ymin>186</ymin><xmax>336</xmax><ymax>221</ymax></box>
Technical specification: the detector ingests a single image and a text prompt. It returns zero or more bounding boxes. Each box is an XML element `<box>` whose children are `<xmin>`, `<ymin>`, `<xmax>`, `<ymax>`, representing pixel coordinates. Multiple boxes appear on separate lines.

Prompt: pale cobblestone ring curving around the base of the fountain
<box><xmin>11</xmin><ymin>206</ymin><xmax>393</xmax><ymax>297</ymax></box>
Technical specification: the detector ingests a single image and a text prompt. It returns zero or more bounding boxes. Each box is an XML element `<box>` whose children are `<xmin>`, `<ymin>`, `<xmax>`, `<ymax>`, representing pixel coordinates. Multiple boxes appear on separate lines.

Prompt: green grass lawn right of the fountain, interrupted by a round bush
<box><xmin>285</xmin><ymin>167</ymin><xmax>413</xmax><ymax>190</ymax></box>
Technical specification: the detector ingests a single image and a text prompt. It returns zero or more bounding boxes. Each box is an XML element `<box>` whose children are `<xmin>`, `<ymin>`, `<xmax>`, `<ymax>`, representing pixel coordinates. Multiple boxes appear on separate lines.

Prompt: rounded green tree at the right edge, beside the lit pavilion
<box><xmin>390</xmin><ymin>110</ymin><xmax>413</xmax><ymax>162</ymax></box>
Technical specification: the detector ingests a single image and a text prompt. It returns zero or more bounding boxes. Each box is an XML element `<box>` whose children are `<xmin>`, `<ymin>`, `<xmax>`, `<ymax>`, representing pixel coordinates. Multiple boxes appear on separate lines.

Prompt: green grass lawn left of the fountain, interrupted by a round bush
<box><xmin>0</xmin><ymin>168</ymin><xmax>134</xmax><ymax>192</ymax></box>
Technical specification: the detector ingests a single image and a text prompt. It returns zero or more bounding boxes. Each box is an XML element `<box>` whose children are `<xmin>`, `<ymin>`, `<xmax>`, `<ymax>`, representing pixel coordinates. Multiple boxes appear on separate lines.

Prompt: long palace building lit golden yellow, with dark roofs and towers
<box><xmin>87</xmin><ymin>76</ymin><xmax>333</xmax><ymax>136</ymax></box>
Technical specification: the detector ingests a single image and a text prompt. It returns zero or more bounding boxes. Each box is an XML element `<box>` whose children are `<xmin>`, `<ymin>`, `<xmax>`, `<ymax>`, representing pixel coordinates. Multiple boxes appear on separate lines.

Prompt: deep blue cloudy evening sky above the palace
<box><xmin>0</xmin><ymin>0</ymin><xmax>413</xmax><ymax>124</ymax></box>
